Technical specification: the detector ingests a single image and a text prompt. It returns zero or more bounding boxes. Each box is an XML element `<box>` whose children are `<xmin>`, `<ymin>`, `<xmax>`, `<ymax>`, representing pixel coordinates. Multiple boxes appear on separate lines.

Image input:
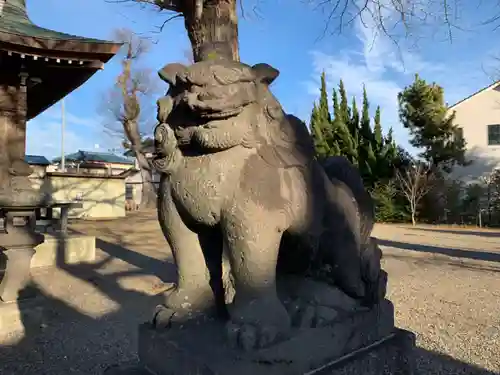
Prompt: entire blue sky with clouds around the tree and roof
<box><xmin>27</xmin><ymin>0</ymin><xmax>500</xmax><ymax>157</ymax></box>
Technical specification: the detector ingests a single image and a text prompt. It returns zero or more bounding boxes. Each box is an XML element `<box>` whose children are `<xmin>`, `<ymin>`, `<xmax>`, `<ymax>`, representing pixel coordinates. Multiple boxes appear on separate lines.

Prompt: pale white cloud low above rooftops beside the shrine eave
<box><xmin>26</xmin><ymin>107</ymin><xmax>121</xmax><ymax>159</ymax></box>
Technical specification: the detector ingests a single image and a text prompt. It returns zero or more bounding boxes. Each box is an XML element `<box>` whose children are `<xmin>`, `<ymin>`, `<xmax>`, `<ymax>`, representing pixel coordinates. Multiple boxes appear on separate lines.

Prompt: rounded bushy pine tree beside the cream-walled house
<box><xmin>398</xmin><ymin>74</ymin><xmax>468</xmax><ymax>171</ymax></box>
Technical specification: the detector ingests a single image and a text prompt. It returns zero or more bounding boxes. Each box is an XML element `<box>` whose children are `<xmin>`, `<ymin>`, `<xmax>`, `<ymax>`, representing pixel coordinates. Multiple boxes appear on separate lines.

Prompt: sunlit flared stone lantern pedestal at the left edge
<box><xmin>0</xmin><ymin>206</ymin><xmax>44</xmax><ymax>302</ymax></box>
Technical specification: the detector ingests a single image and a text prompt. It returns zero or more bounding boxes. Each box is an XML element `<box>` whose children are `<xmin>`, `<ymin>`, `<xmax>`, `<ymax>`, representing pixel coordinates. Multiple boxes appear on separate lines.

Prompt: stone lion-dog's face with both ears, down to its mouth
<box><xmin>158</xmin><ymin>61</ymin><xmax>279</xmax><ymax>127</ymax></box>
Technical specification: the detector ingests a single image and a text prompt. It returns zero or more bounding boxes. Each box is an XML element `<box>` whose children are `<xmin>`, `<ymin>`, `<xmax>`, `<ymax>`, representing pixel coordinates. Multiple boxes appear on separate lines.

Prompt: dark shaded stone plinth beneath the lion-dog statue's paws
<box><xmin>122</xmin><ymin>300</ymin><xmax>414</xmax><ymax>375</ymax></box>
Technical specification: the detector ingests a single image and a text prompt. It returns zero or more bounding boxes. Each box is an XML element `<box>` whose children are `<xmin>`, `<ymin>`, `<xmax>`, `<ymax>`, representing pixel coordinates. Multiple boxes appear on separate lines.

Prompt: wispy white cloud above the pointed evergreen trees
<box><xmin>306</xmin><ymin>2</ymin><xmax>488</xmax><ymax>153</ymax></box>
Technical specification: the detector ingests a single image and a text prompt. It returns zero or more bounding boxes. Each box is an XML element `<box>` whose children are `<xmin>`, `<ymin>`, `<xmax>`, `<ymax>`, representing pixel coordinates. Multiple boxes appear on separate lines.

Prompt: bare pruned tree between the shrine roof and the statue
<box><xmin>103</xmin><ymin>29</ymin><xmax>156</xmax><ymax>212</ymax></box>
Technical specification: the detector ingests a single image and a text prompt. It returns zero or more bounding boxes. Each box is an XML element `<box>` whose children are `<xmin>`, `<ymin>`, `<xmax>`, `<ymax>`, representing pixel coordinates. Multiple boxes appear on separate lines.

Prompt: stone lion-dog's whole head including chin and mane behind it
<box><xmin>154</xmin><ymin>60</ymin><xmax>314</xmax><ymax>166</ymax></box>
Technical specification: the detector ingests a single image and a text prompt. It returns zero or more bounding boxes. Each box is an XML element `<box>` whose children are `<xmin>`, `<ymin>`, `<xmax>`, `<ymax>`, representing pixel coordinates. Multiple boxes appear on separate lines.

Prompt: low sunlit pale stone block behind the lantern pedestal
<box><xmin>31</xmin><ymin>234</ymin><xmax>96</xmax><ymax>268</ymax></box>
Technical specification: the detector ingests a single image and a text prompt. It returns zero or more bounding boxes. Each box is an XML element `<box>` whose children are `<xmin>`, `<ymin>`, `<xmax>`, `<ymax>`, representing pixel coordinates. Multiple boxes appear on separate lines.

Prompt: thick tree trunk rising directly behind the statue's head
<box><xmin>182</xmin><ymin>0</ymin><xmax>240</xmax><ymax>62</ymax></box>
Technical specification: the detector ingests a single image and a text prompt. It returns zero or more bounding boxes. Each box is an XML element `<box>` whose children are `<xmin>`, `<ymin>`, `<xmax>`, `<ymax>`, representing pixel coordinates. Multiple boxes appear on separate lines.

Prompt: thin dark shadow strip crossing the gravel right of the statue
<box><xmin>377</xmin><ymin>238</ymin><xmax>500</xmax><ymax>262</ymax></box>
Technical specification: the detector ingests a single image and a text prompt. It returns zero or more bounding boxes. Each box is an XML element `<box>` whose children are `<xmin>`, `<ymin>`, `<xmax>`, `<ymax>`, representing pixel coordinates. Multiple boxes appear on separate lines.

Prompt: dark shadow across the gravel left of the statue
<box><xmin>0</xmin><ymin>213</ymin><xmax>175</xmax><ymax>375</ymax></box>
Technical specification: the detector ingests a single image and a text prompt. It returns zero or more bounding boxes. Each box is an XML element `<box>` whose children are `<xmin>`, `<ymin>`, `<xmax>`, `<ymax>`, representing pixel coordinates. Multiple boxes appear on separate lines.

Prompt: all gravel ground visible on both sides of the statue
<box><xmin>0</xmin><ymin>213</ymin><xmax>500</xmax><ymax>375</ymax></box>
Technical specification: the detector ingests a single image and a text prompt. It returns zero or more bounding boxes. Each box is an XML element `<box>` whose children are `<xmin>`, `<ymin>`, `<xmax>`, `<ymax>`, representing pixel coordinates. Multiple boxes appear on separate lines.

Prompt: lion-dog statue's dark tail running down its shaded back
<box><xmin>321</xmin><ymin>156</ymin><xmax>387</xmax><ymax>305</ymax></box>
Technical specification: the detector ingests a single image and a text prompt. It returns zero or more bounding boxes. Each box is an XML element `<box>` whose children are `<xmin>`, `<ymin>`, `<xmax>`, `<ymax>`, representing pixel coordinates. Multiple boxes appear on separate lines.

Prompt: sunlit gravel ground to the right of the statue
<box><xmin>374</xmin><ymin>225</ymin><xmax>500</xmax><ymax>375</ymax></box>
